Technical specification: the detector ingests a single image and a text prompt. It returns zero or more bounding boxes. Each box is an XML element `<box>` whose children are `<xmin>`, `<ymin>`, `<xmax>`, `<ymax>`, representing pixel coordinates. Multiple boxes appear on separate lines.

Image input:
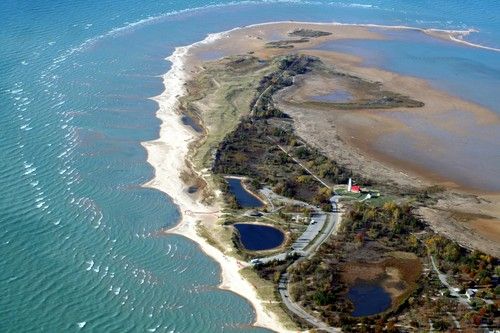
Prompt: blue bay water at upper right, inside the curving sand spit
<box><xmin>318</xmin><ymin>29</ymin><xmax>500</xmax><ymax>111</ymax></box>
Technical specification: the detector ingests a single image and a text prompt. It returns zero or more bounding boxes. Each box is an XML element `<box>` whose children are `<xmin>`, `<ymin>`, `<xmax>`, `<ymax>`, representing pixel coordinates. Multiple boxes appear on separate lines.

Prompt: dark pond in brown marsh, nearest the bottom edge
<box><xmin>347</xmin><ymin>282</ymin><xmax>391</xmax><ymax>317</ymax></box>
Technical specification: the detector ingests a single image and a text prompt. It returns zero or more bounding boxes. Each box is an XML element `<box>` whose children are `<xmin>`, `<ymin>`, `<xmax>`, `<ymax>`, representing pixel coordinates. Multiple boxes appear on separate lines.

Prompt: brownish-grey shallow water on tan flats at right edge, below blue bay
<box><xmin>375</xmin><ymin>110</ymin><xmax>500</xmax><ymax>192</ymax></box>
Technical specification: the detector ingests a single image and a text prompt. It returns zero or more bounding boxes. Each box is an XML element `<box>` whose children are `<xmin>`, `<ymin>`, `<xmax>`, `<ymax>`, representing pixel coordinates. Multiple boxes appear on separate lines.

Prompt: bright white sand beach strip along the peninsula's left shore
<box><xmin>142</xmin><ymin>33</ymin><xmax>290</xmax><ymax>332</ymax></box>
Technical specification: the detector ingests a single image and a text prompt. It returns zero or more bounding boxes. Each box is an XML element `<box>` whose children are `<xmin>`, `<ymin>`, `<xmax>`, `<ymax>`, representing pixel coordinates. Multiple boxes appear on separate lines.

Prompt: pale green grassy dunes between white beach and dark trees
<box><xmin>181</xmin><ymin>56</ymin><xmax>274</xmax><ymax>170</ymax></box>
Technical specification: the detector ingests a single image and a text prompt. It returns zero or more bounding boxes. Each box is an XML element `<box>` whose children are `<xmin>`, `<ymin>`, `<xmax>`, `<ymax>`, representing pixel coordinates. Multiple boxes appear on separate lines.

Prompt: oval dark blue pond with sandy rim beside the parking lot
<box><xmin>234</xmin><ymin>223</ymin><xmax>285</xmax><ymax>251</ymax></box>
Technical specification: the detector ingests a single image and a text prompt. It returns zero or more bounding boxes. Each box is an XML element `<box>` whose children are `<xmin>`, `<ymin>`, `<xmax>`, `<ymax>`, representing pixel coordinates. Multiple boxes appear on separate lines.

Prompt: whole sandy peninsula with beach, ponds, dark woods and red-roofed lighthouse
<box><xmin>144</xmin><ymin>22</ymin><xmax>500</xmax><ymax>332</ymax></box>
